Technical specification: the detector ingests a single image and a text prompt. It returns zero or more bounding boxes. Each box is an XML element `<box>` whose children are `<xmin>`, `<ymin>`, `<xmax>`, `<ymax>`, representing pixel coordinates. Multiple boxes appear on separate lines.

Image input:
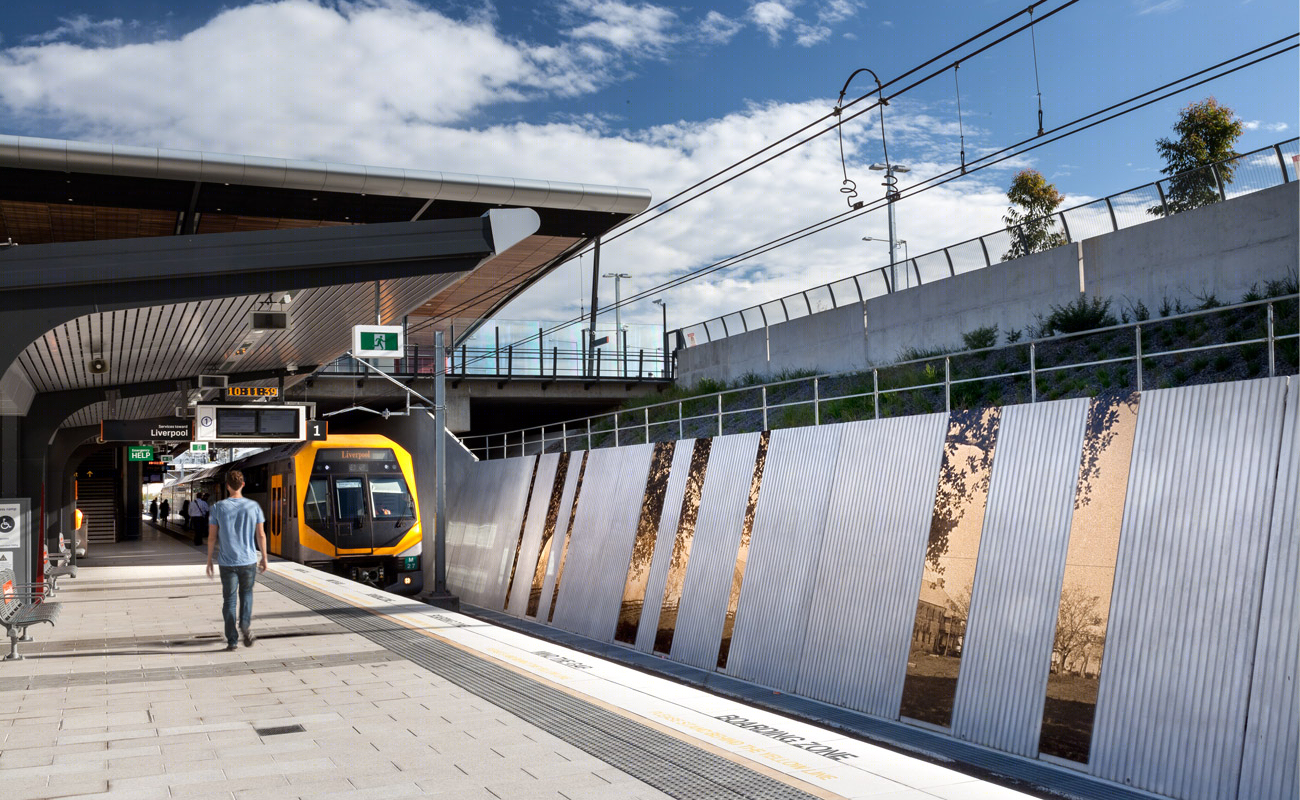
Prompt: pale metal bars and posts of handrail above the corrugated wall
<box><xmin>464</xmin><ymin>294</ymin><xmax>1300</xmax><ymax>458</ymax></box>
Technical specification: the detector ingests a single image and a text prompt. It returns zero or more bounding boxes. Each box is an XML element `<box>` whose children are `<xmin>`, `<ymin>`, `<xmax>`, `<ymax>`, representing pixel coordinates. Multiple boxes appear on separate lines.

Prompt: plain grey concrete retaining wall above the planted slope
<box><xmin>677</xmin><ymin>182</ymin><xmax>1300</xmax><ymax>386</ymax></box>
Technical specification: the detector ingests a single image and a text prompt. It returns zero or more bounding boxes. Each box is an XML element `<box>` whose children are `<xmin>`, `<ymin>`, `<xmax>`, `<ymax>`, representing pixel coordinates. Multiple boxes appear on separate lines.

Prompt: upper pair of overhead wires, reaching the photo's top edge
<box><xmin>412</xmin><ymin>0</ymin><xmax>1079</xmax><ymax>340</ymax></box>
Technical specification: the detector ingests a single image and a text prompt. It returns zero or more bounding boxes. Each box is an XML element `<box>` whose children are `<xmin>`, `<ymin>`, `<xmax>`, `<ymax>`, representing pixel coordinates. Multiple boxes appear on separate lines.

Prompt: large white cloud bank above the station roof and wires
<box><xmin>0</xmin><ymin>0</ymin><xmax>1030</xmax><ymax>331</ymax></box>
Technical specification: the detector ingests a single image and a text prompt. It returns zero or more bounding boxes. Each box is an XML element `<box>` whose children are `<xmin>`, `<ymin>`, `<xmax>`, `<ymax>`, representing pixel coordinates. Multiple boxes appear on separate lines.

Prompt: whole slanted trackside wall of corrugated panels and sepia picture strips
<box><xmin>449</xmin><ymin>377</ymin><xmax>1300</xmax><ymax>800</ymax></box>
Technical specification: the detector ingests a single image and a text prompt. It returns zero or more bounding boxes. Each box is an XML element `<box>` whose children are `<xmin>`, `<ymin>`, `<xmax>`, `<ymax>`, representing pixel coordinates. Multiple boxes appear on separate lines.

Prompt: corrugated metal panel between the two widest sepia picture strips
<box><xmin>953</xmin><ymin>398</ymin><xmax>1088</xmax><ymax>757</ymax></box>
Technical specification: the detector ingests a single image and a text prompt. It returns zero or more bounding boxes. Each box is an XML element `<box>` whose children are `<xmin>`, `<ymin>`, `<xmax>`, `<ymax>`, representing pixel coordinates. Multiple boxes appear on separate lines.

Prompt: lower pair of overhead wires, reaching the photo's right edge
<box><xmin>431</xmin><ymin>33</ymin><xmax>1300</xmax><ymax>372</ymax></box>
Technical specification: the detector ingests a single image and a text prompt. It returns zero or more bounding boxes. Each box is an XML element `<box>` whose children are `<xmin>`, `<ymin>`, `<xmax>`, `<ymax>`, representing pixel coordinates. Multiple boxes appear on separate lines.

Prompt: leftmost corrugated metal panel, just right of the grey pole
<box><xmin>447</xmin><ymin>455</ymin><xmax>537</xmax><ymax>609</ymax></box>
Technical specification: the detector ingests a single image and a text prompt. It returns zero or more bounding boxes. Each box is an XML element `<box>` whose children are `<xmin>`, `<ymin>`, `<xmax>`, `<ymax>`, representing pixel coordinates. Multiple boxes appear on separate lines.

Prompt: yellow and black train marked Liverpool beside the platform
<box><xmin>160</xmin><ymin>434</ymin><xmax>423</xmax><ymax>593</ymax></box>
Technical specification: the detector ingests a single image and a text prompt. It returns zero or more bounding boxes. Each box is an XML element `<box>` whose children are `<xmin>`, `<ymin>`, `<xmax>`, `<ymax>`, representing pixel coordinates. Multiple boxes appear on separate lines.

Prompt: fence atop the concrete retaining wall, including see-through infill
<box><xmin>675</xmin><ymin>138</ymin><xmax>1300</xmax><ymax>347</ymax></box>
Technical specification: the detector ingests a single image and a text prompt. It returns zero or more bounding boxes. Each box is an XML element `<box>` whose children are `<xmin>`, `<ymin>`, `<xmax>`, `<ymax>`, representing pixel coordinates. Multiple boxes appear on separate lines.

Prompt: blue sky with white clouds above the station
<box><xmin>0</xmin><ymin>0</ymin><xmax>1300</xmax><ymax>324</ymax></box>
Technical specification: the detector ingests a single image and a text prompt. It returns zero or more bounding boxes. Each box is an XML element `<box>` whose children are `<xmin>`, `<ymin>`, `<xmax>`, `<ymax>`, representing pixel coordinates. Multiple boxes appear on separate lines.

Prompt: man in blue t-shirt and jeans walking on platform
<box><xmin>208</xmin><ymin>470</ymin><xmax>267</xmax><ymax>650</ymax></box>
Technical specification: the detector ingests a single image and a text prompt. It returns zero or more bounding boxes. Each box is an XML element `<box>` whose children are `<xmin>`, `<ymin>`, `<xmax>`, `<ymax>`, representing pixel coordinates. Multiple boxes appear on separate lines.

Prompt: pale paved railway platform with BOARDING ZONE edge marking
<box><xmin>0</xmin><ymin>526</ymin><xmax>1044</xmax><ymax>800</ymax></box>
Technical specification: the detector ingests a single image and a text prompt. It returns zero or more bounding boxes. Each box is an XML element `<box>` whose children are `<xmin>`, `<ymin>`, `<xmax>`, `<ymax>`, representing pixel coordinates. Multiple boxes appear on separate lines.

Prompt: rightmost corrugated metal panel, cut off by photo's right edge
<box><xmin>1238</xmin><ymin>379</ymin><xmax>1300</xmax><ymax>800</ymax></box>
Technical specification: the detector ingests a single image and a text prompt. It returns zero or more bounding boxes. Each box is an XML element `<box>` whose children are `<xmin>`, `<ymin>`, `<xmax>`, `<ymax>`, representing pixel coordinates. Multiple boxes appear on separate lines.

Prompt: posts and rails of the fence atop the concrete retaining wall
<box><xmin>670</xmin><ymin>137</ymin><xmax>1300</xmax><ymax>345</ymax></box>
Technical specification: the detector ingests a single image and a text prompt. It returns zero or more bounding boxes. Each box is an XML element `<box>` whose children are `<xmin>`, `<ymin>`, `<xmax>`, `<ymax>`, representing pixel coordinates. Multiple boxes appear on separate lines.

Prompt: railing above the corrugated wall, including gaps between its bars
<box><xmin>463</xmin><ymin>293</ymin><xmax>1300</xmax><ymax>459</ymax></box>
